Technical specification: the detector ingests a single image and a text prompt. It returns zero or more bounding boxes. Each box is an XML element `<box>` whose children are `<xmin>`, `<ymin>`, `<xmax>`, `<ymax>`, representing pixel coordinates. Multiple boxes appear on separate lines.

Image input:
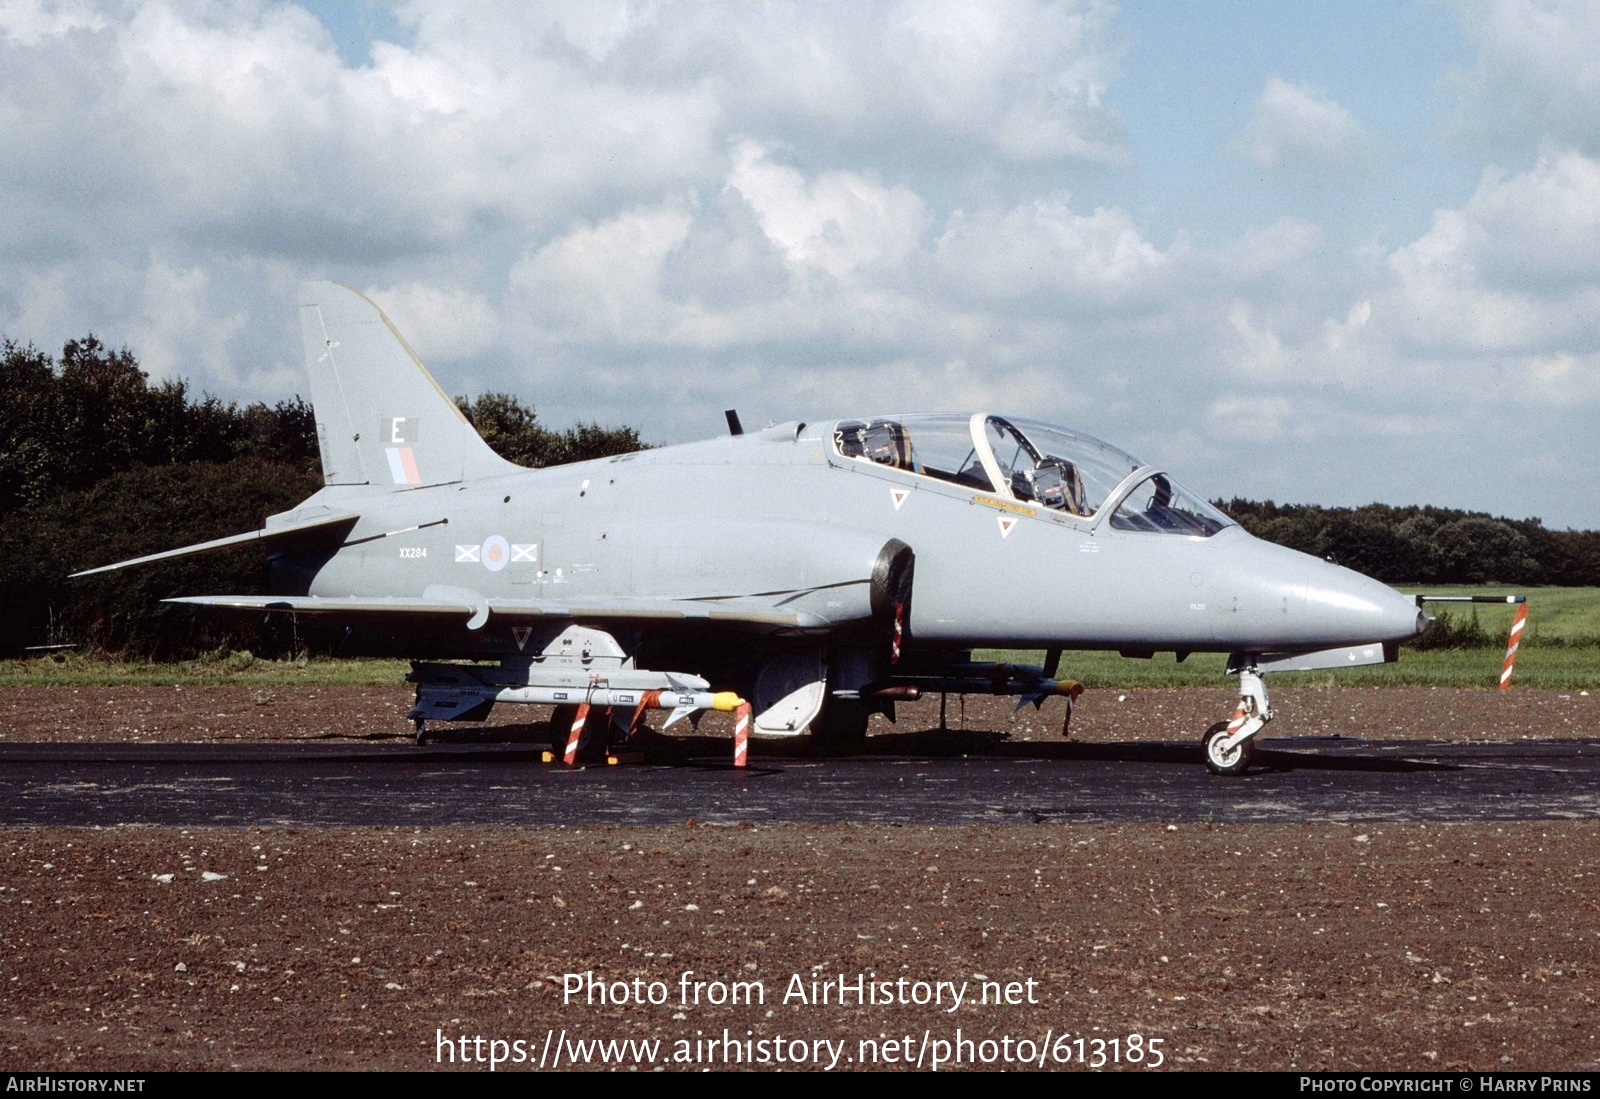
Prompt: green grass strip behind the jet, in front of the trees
<box><xmin>0</xmin><ymin>585</ymin><xmax>1600</xmax><ymax>689</ymax></box>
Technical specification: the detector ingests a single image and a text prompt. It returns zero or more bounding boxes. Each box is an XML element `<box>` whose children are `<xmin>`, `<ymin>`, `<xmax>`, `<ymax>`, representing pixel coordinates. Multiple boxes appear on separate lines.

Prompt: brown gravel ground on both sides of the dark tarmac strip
<box><xmin>0</xmin><ymin>688</ymin><xmax>1600</xmax><ymax>1072</ymax></box>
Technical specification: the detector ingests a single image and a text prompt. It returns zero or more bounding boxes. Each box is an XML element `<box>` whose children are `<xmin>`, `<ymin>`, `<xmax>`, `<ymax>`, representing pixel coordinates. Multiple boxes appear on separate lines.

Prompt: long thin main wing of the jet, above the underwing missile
<box><xmin>165</xmin><ymin>592</ymin><xmax>829</xmax><ymax>629</ymax></box>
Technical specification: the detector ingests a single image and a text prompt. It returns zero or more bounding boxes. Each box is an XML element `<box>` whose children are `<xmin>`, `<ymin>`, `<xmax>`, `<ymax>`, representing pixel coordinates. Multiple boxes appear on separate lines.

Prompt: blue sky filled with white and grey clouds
<box><xmin>0</xmin><ymin>0</ymin><xmax>1600</xmax><ymax>528</ymax></box>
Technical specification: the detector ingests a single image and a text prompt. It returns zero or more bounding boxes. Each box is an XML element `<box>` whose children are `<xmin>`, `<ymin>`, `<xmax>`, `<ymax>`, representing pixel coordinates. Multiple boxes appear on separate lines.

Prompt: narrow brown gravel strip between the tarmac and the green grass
<box><xmin>0</xmin><ymin>685</ymin><xmax>1600</xmax><ymax>753</ymax></box>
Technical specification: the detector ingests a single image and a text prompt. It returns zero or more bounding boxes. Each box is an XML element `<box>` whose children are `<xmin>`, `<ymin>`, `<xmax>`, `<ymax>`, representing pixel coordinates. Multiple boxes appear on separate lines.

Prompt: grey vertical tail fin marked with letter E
<box><xmin>301</xmin><ymin>282</ymin><xmax>517</xmax><ymax>491</ymax></box>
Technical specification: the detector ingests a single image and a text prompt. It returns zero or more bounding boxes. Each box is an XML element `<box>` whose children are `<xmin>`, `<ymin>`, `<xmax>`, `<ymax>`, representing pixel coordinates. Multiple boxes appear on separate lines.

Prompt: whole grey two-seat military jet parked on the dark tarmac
<box><xmin>80</xmin><ymin>283</ymin><xmax>1426</xmax><ymax>774</ymax></box>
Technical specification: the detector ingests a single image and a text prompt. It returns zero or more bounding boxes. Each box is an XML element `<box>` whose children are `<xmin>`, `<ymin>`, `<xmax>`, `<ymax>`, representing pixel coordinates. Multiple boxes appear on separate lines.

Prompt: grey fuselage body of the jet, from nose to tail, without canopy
<box><xmin>275</xmin><ymin>422</ymin><xmax>1418</xmax><ymax>653</ymax></box>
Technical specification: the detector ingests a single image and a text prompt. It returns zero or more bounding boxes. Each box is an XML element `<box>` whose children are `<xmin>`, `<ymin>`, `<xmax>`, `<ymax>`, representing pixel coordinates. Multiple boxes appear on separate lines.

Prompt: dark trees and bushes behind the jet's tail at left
<box><xmin>0</xmin><ymin>336</ymin><xmax>643</xmax><ymax>659</ymax></box>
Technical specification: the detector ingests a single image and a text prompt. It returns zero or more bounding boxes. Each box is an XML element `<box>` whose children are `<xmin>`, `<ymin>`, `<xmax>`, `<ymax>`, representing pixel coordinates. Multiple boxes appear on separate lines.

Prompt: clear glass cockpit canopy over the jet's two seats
<box><xmin>834</xmin><ymin>413</ymin><xmax>1232</xmax><ymax>538</ymax></box>
